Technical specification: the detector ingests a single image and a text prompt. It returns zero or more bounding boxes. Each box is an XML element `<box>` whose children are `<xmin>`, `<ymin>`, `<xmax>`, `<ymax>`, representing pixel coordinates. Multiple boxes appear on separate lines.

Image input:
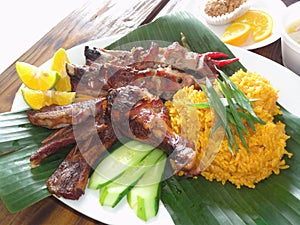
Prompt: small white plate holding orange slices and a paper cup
<box><xmin>181</xmin><ymin>0</ymin><xmax>286</xmax><ymax>50</ymax></box>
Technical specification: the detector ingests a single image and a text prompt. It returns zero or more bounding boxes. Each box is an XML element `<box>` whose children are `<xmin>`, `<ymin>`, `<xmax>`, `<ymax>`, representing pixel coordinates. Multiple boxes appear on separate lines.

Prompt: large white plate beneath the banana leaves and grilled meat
<box><xmin>12</xmin><ymin>36</ymin><xmax>300</xmax><ymax>225</ymax></box>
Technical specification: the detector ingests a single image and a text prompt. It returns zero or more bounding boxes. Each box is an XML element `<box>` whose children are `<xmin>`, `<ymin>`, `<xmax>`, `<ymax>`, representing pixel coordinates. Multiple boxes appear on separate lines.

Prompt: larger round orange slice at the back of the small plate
<box><xmin>234</xmin><ymin>10</ymin><xmax>273</xmax><ymax>42</ymax></box>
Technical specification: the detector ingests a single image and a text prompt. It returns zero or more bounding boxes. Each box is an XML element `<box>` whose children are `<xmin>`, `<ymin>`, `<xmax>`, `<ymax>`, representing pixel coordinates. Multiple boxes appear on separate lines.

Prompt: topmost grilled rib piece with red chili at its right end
<box><xmin>84</xmin><ymin>42</ymin><xmax>238</xmax><ymax>76</ymax></box>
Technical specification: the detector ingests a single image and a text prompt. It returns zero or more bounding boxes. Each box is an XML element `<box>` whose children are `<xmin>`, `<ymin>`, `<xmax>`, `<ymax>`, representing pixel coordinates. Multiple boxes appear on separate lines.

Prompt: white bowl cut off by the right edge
<box><xmin>281</xmin><ymin>2</ymin><xmax>300</xmax><ymax>75</ymax></box>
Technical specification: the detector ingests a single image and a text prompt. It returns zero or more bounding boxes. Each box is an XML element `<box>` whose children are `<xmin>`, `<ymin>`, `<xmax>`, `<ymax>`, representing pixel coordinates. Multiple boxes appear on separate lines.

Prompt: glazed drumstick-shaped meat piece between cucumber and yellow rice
<box><xmin>107</xmin><ymin>86</ymin><xmax>197</xmax><ymax>173</ymax></box>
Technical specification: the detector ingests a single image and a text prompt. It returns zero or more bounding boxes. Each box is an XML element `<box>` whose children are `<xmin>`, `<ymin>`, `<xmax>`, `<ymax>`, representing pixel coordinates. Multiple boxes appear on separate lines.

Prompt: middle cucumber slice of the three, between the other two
<box><xmin>100</xmin><ymin>149</ymin><xmax>164</xmax><ymax>208</ymax></box>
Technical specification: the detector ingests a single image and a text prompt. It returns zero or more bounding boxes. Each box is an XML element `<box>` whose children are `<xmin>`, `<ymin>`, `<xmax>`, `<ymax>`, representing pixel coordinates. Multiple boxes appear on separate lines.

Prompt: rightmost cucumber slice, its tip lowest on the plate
<box><xmin>127</xmin><ymin>154</ymin><xmax>167</xmax><ymax>221</ymax></box>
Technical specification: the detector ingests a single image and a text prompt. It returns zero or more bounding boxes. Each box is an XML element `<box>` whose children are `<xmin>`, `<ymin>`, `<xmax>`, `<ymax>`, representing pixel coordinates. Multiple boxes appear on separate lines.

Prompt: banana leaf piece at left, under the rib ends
<box><xmin>0</xmin><ymin>111</ymin><xmax>68</xmax><ymax>212</ymax></box>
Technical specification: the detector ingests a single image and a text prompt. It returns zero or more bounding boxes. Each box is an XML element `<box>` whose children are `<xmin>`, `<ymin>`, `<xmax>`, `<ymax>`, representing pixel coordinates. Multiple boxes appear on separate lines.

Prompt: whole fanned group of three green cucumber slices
<box><xmin>88</xmin><ymin>141</ymin><xmax>167</xmax><ymax>221</ymax></box>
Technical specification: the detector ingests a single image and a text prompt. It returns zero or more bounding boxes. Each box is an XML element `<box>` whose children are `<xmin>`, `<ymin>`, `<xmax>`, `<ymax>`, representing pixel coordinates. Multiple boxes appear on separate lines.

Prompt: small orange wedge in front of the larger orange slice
<box><xmin>221</xmin><ymin>23</ymin><xmax>251</xmax><ymax>46</ymax></box>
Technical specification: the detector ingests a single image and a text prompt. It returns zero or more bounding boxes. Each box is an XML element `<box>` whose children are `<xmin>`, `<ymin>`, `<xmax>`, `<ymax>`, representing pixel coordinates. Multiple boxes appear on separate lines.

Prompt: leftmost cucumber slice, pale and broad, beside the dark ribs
<box><xmin>88</xmin><ymin>140</ymin><xmax>154</xmax><ymax>190</ymax></box>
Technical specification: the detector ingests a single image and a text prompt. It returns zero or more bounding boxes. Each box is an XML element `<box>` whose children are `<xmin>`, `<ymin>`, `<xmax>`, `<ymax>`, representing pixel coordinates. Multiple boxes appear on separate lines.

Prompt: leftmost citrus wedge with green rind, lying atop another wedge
<box><xmin>16</xmin><ymin>62</ymin><xmax>61</xmax><ymax>90</ymax></box>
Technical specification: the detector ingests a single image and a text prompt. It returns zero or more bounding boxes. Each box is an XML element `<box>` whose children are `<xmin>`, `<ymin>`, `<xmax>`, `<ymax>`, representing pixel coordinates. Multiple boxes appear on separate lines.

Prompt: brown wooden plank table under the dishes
<box><xmin>0</xmin><ymin>0</ymin><xmax>297</xmax><ymax>225</ymax></box>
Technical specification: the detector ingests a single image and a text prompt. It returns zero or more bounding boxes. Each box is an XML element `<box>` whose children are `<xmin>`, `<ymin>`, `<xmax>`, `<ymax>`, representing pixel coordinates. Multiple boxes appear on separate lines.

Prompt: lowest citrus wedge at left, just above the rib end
<box><xmin>21</xmin><ymin>87</ymin><xmax>76</xmax><ymax>109</ymax></box>
